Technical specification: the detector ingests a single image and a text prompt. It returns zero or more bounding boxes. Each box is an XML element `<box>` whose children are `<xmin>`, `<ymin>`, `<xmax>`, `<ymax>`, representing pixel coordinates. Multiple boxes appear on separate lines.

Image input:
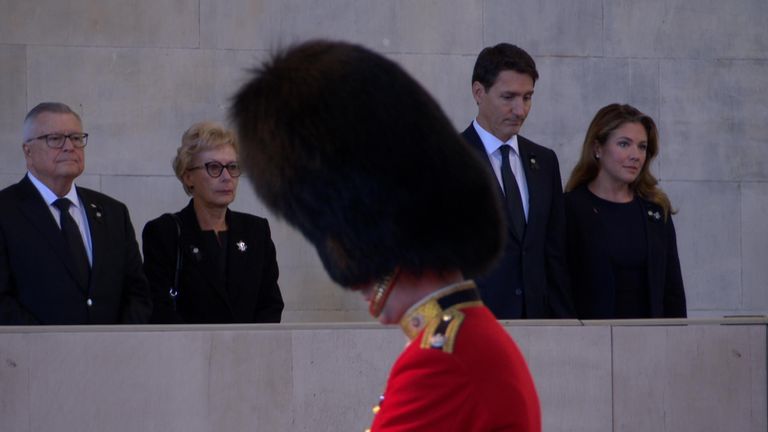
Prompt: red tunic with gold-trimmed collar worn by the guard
<box><xmin>372</xmin><ymin>283</ymin><xmax>541</xmax><ymax>432</ymax></box>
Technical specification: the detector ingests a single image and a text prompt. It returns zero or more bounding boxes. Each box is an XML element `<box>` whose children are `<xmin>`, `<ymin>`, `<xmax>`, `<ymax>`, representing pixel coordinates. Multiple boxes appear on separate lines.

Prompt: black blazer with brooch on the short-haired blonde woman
<box><xmin>142</xmin><ymin>200</ymin><xmax>283</xmax><ymax>324</ymax></box>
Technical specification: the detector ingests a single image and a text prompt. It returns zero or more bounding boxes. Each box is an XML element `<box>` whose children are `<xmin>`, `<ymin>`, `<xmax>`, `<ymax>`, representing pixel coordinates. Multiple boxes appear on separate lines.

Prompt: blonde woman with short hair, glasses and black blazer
<box><xmin>142</xmin><ymin>122</ymin><xmax>283</xmax><ymax>324</ymax></box>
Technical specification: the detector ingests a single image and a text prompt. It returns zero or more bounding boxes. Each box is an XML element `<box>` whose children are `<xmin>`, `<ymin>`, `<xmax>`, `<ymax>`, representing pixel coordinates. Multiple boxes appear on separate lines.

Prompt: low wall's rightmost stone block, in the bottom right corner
<box><xmin>613</xmin><ymin>326</ymin><xmax>766</xmax><ymax>432</ymax></box>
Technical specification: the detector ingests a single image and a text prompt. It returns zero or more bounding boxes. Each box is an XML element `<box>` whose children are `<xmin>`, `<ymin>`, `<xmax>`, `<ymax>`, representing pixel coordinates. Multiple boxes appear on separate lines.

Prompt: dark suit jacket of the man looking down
<box><xmin>461</xmin><ymin>124</ymin><xmax>575</xmax><ymax>319</ymax></box>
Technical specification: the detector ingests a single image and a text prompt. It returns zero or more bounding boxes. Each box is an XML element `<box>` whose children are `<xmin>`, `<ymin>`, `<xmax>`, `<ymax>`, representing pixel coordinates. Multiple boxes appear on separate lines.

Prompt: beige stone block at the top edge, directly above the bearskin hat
<box><xmin>200</xmin><ymin>0</ymin><xmax>482</xmax><ymax>53</ymax></box>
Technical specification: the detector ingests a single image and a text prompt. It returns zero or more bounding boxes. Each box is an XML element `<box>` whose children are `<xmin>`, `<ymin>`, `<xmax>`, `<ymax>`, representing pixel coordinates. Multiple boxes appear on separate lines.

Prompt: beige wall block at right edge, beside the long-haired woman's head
<box><xmin>659</xmin><ymin>60</ymin><xmax>768</xmax><ymax>181</ymax></box>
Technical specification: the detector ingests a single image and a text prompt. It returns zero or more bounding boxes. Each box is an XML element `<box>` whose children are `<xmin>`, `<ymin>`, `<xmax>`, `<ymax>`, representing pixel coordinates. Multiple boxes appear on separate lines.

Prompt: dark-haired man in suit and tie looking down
<box><xmin>462</xmin><ymin>43</ymin><xmax>575</xmax><ymax>319</ymax></box>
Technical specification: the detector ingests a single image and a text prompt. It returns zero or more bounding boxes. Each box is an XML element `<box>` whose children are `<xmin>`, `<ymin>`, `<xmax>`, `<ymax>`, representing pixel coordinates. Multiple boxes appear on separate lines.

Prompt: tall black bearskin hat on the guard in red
<box><xmin>230</xmin><ymin>40</ymin><xmax>504</xmax><ymax>287</ymax></box>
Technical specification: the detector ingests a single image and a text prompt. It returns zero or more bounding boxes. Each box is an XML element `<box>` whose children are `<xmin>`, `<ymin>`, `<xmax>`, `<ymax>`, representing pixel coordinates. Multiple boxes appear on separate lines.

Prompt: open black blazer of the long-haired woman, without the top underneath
<box><xmin>565</xmin><ymin>185</ymin><xmax>687</xmax><ymax>319</ymax></box>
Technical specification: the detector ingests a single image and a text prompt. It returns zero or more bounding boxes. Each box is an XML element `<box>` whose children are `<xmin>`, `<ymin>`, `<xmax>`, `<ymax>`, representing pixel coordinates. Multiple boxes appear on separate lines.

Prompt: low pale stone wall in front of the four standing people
<box><xmin>0</xmin><ymin>319</ymin><xmax>768</xmax><ymax>432</ymax></box>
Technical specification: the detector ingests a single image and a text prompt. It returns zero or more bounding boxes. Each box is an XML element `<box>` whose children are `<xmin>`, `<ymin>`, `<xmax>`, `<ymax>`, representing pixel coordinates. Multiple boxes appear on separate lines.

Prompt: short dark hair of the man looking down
<box><xmin>472</xmin><ymin>43</ymin><xmax>539</xmax><ymax>91</ymax></box>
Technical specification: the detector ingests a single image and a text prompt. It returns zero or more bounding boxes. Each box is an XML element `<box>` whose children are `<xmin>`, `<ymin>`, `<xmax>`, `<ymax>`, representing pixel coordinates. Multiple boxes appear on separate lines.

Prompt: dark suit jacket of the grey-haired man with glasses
<box><xmin>0</xmin><ymin>176</ymin><xmax>152</xmax><ymax>325</ymax></box>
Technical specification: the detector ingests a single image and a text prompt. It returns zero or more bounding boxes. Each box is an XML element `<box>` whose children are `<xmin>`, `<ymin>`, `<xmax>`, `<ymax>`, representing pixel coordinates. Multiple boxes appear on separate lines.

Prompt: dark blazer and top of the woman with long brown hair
<box><xmin>565</xmin><ymin>185</ymin><xmax>687</xmax><ymax>319</ymax></box>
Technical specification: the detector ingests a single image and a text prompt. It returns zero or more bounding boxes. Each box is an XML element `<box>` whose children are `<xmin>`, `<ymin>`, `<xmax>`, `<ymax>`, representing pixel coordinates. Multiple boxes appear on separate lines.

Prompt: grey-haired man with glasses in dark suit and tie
<box><xmin>0</xmin><ymin>102</ymin><xmax>152</xmax><ymax>325</ymax></box>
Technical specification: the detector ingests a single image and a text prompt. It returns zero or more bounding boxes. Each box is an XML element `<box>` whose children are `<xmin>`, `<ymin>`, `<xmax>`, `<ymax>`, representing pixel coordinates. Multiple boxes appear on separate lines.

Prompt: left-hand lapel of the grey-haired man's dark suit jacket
<box><xmin>20</xmin><ymin>177</ymin><xmax>87</xmax><ymax>291</ymax></box>
